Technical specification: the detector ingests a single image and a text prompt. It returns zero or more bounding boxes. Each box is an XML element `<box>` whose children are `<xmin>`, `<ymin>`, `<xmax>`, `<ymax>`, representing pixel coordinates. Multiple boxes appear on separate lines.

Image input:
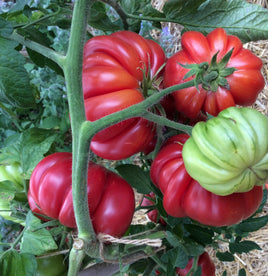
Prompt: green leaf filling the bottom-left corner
<box><xmin>0</xmin><ymin>250</ymin><xmax>37</xmax><ymax>276</ymax></box>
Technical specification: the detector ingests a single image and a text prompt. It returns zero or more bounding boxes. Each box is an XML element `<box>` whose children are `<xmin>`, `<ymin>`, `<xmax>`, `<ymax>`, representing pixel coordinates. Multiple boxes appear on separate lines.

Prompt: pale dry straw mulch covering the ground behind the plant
<box><xmin>134</xmin><ymin>0</ymin><xmax>268</xmax><ymax>276</ymax></box>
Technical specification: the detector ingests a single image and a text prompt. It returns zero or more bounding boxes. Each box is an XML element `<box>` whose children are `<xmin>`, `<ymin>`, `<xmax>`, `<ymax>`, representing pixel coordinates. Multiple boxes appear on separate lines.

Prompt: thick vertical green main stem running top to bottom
<box><xmin>63</xmin><ymin>0</ymin><xmax>96</xmax><ymax>276</ymax></box>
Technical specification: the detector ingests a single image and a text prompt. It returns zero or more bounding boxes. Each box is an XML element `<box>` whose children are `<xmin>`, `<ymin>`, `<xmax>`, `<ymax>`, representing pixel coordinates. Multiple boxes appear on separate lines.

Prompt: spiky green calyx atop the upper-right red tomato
<box><xmin>180</xmin><ymin>49</ymin><xmax>236</xmax><ymax>92</ymax></box>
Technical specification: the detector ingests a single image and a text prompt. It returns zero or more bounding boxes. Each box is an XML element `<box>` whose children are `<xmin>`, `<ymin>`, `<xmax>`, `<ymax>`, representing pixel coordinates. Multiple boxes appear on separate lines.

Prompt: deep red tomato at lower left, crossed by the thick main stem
<box><xmin>28</xmin><ymin>152</ymin><xmax>135</xmax><ymax>237</ymax></box>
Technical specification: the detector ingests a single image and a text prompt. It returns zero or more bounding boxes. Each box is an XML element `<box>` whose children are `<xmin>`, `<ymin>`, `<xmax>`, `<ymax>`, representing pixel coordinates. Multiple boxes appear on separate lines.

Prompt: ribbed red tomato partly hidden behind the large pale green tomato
<box><xmin>150</xmin><ymin>134</ymin><xmax>263</xmax><ymax>226</ymax></box>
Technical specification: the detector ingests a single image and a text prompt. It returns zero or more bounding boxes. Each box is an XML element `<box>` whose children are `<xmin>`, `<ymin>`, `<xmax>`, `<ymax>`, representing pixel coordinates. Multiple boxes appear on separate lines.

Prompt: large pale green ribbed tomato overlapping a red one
<box><xmin>182</xmin><ymin>107</ymin><xmax>268</xmax><ymax>196</ymax></box>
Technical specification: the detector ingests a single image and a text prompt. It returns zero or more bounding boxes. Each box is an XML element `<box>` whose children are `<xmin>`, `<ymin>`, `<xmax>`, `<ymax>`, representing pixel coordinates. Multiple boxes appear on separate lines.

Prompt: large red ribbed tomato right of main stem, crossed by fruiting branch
<box><xmin>82</xmin><ymin>31</ymin><xmax>165</xmax><ymax>160</ymax></box>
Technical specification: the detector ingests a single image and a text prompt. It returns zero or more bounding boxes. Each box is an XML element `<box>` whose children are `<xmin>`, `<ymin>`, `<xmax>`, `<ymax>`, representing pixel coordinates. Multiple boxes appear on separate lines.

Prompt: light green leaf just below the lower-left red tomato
<box><xmin>20</xmin><ymin>212</ymin><xmax>58</xmax><ymax>255</ymax></box>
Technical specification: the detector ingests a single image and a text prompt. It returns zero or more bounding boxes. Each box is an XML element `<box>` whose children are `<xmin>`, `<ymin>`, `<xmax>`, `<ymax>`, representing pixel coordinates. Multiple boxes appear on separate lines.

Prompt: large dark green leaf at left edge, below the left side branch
<box><xmin>0</xmin><ymin>37</ymin><xmax>35</xmax><ymax>108</ymax></box>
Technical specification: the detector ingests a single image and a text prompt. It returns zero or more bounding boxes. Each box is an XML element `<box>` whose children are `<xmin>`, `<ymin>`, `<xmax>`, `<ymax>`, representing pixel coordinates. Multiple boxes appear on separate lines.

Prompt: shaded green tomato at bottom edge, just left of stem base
<box><xmin>35</xmin><ymin>255</ymin><xmax>67</xmax><ymax>276</ymax></box>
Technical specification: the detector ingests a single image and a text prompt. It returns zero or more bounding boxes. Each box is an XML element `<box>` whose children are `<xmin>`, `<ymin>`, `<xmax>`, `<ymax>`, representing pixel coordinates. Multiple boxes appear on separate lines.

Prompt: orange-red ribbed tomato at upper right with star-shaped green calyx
<box><xmin>164</xmin><ymin>28</ymin><xmax>265</xmax><ymax>118</ymax></box>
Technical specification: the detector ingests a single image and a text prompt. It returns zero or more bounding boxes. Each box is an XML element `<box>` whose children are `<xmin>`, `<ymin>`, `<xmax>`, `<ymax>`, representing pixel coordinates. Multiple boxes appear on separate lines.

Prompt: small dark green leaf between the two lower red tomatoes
<box><xmin>116</xmin><ymin>164</ymin><xmax>152</xmax><ymax>194</ymax></box>
